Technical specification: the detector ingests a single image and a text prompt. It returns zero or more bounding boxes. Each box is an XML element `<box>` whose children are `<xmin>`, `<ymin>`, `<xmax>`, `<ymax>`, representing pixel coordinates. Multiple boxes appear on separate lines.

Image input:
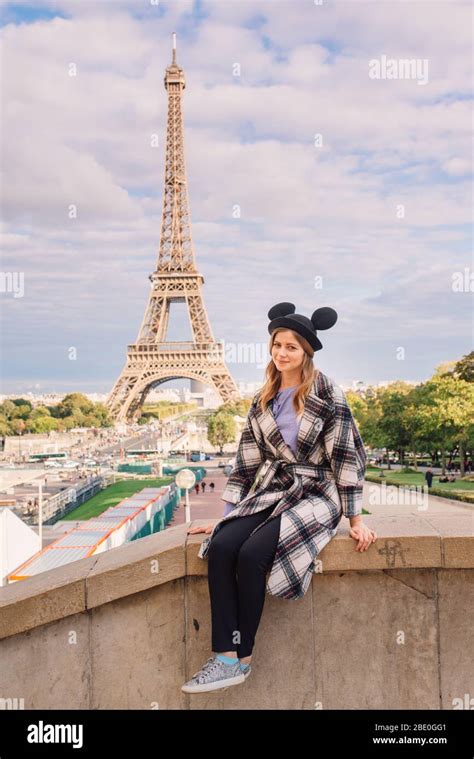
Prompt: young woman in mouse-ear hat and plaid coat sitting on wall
<box><xmin>182</xmin><ymin>303</ymin><xmax>377</xmax><ymax>693</ymax></box>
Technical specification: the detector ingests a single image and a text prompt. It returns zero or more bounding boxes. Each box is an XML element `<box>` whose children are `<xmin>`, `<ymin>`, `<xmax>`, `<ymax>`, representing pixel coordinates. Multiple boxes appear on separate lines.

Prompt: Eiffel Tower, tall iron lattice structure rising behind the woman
<box><xmin>106</xmin><ymin>33</ymin><xmax>240</xmax><ymax>421</ymax></box>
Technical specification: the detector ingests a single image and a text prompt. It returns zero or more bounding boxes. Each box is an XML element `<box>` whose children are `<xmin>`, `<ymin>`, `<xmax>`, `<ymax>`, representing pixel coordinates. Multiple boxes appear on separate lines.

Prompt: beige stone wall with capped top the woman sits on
<box><xmin>0</xmin><ymin>513</ymin><xmax>474</xmax><ymax>709</ymax></box>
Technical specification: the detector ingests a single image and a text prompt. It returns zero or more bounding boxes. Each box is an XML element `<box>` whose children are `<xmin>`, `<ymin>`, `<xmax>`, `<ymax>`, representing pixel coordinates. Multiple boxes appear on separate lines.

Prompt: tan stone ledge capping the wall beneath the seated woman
<box><xmin>0</xmin><ymin>514</ymin><xmax>474</xmax><ymax>639</ymax></box>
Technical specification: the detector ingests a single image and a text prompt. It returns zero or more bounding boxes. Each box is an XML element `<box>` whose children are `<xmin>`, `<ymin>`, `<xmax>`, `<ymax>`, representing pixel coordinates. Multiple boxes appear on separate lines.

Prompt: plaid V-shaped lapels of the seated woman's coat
<box><xmin>256</xmin><ymin>372</ymin><xmax>334</xmax><ymax>462</ymax></box>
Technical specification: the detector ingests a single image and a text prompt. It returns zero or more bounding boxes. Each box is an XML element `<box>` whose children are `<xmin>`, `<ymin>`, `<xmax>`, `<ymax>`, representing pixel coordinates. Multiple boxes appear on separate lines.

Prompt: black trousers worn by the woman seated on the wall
<box><xmin>208</xmin><ymin>505</ymin><xmax>281</xmax><ymax>658</ymax></box>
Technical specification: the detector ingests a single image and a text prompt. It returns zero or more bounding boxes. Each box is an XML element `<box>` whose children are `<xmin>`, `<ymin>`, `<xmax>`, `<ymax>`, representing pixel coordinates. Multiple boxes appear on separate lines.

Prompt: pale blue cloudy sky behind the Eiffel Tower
<box><xmin>0</xmin><ymin>0</ymin><xmax>473</xmax><ymax>393</ymax></box>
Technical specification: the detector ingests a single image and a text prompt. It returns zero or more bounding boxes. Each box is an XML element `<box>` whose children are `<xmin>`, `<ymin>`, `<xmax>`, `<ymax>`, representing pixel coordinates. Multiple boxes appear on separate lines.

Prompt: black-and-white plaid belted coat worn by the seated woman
<box><xmin>198</xmin><ymin>371</ymin><xmax>366</xmax><ymax>599</ymax></box>
